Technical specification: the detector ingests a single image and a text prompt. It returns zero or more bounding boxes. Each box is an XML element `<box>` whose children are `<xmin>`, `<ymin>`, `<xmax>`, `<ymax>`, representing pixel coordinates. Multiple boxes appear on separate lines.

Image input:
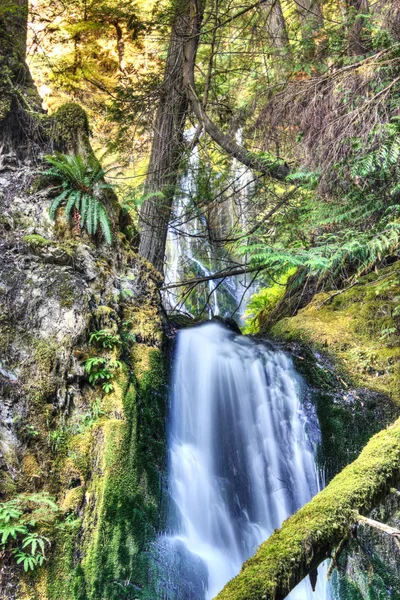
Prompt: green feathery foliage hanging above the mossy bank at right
<box><xmin>239</xmin><ymin>118</ymin><xmax>400</xmax><ymax>285</ymax></box>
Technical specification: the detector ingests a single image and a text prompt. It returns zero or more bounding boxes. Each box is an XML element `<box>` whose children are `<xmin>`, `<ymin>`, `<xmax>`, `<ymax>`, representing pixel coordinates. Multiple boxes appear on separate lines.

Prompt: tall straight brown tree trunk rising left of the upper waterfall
<box><xmin>139</xmin><ymin>0</ymin><xmax>205</xmax><ymax>272</ymax></box>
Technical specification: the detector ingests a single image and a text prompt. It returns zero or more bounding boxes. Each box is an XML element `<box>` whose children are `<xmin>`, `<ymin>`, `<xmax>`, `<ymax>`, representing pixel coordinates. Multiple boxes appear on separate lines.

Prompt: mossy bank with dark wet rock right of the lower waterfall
<box><xmin>269</xmin><ymin>262</ymin><xmax>400</xmax><ymax>600</ymax></box>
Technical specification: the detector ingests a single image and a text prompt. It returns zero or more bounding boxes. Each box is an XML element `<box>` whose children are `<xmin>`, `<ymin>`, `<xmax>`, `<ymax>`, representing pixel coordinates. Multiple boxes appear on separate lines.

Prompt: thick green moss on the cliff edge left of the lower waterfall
<box><xmin>46</xmin><ymin>342</ymin><xmax>166</xmax><ymax>600</ymax></box>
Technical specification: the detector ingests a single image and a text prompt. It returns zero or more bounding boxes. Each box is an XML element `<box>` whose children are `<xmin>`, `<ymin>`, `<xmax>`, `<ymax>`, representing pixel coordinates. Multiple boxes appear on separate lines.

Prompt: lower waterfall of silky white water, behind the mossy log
<box><xmin>165</xmin><ymin>322</ymin><xmax>327</xmax><ymax>600</ymax></box>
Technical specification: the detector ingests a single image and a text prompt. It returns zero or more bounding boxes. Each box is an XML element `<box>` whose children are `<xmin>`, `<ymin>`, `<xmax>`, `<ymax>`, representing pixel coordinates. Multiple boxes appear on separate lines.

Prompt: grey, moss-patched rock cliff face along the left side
<box><xmin>0</xmin><ymin>137</ymin><xmax>167</xmax><ymax>600</ymax></box>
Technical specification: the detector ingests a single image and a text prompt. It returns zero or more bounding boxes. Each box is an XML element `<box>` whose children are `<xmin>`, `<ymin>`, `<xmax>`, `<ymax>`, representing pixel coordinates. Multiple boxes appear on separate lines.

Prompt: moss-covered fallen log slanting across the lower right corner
<box><xmin>217</xmin><ymin>419</ymin><xmax>400</xmax><ymax>600</ymax></box>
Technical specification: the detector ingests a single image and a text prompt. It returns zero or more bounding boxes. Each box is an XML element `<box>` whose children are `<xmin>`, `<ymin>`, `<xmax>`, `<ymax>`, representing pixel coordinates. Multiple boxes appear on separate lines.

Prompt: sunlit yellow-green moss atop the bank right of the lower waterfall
<box><xmin>271</xmin><ymin>262</ymin><xmax>400</xmax><ymax>404</ymax></box>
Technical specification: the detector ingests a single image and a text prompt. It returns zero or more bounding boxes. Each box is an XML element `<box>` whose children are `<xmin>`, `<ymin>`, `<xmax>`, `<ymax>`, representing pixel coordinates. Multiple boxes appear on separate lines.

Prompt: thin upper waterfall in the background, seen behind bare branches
<box><xmin>164</xmin><ymin>128</ymin><xmax>254</xmax><ymax>318</ymax></box>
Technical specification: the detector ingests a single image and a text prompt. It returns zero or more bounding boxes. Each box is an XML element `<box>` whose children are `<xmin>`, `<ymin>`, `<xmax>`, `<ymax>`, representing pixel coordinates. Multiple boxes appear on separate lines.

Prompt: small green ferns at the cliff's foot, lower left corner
<box><xmin>0</xmin><ymin>493</ymin><xmax>58</xmax><ymax>571</ymax></box>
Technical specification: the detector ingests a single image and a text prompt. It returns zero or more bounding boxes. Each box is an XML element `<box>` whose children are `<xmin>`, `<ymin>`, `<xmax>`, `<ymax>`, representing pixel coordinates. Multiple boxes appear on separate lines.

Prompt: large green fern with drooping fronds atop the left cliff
<box><xmin>44</xmin><ymin>152</ymin><xmax>112</xmax><ymax>244</ymax></box>
